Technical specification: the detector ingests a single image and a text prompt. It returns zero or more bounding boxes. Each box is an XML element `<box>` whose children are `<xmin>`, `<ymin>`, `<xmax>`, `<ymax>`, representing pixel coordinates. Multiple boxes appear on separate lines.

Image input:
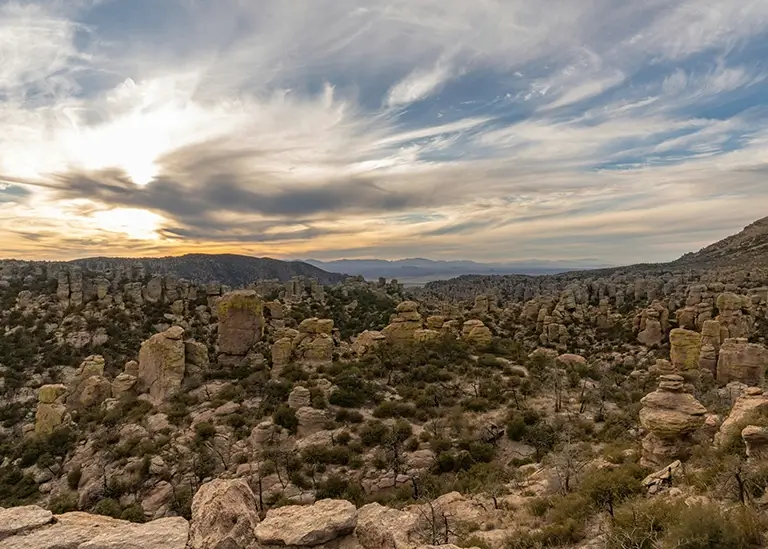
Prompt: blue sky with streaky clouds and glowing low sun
<box><xmin>0</xmin><ymin>0</ymin><xmax>768</xmax><ymax>264</ymax></box>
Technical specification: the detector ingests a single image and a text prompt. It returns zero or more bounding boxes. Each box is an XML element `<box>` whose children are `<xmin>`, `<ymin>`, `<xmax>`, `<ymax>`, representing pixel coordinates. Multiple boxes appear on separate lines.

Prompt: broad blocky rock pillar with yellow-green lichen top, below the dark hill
<box><xmin>216</xmin><ymin>290</ymin><xmax>264</xmax><ymax>356</ymax></box>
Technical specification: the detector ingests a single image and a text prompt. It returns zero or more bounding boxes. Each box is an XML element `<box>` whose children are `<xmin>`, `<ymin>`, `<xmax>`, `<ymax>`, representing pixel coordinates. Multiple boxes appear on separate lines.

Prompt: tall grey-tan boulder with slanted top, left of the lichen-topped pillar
<box><xmin>136</xmin><ymin>326</ymin><xmax>185</xmax><ymax>402</ymax></box>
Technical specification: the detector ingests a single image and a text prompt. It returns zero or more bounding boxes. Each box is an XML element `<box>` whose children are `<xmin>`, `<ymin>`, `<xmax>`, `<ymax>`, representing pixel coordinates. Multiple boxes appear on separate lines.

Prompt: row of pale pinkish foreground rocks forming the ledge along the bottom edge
<box><xmin>0</xmin><ymin>479</ymin><xmax>472</xmax><ymax>549</ymax></box>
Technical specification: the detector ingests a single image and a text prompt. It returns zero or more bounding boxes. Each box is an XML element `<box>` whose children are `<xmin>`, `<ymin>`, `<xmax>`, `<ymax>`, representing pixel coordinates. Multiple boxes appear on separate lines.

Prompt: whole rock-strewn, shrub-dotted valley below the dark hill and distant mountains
<box><xmin>0</xmin><ymin>216</ymin><xmax>768</xmax><ymax>549</ymax></box>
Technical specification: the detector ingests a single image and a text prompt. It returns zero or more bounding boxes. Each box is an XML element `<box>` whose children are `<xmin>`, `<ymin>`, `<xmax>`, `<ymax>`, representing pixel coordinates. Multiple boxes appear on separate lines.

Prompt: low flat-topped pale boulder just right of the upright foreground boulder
<box><xmin>255</xmin><ymin>499</ymin><xmax>357</xmax><ymax>547</ymax></box>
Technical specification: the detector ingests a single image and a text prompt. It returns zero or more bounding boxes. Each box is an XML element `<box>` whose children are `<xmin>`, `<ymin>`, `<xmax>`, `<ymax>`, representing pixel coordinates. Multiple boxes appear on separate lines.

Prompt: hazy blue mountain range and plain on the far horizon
<box><xmin>304</xmin><ymin>258</ymin><xmax>609</xmax><ymax>285</ymax></box>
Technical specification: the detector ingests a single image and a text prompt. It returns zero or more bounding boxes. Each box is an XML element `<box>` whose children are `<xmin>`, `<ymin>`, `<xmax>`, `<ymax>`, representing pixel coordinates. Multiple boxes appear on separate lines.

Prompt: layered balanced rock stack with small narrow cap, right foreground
<box><xmin>640</xmin><ymin>375</ymin><xmax>707</xmax><ymax>467</ymax></box>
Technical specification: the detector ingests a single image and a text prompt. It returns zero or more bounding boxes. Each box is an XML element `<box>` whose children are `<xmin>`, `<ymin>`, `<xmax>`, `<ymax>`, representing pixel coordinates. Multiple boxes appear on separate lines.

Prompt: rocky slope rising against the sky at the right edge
<box><xmin>673</xmin><ymin>217</ymin><xmax>768</xmax><ymax>268</ymax></box>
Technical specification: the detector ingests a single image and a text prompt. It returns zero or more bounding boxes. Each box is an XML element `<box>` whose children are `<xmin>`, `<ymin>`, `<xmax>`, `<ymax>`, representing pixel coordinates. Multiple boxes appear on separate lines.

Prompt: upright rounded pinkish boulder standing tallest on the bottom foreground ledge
<box><xmin>188</xmin><ymin>479</ymin><xmax>259</xmax><ymax>549</ymax></box>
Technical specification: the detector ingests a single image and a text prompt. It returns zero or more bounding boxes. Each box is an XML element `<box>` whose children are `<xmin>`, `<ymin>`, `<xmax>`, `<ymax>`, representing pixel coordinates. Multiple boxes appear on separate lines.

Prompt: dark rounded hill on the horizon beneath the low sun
<box><xmin>70</xmin><ymin>254</ymin><xmax>346</xmax><ymax>288</ymax></box>
